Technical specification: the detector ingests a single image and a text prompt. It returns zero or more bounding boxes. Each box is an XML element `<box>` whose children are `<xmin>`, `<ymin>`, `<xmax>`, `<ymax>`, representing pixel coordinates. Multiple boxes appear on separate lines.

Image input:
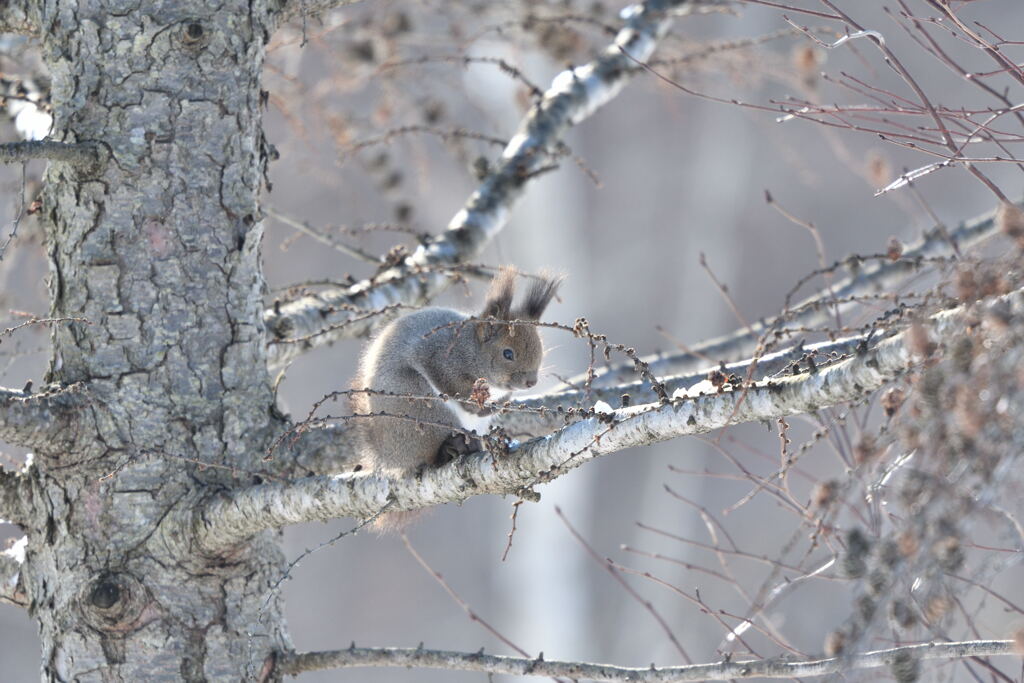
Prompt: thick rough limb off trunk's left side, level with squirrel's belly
<box><xmin>0</xmin><ymin>385</ymin><xmax>83</xmax><ymax>453</ymax></box>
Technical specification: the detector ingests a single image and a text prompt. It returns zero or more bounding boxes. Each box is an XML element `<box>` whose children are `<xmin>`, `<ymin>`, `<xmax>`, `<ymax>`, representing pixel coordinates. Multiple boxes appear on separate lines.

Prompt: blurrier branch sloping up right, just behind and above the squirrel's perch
<box><xmin>568</xmin><ymin>205</ymin><xmax>1007</xmax><ymax>388</ymax></box>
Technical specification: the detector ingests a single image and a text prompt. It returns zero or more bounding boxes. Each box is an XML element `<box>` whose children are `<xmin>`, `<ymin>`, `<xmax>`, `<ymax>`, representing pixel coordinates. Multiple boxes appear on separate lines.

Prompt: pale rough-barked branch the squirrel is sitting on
<box><xmin>193</xmin><ymin>290</ymin><xmax>1024</xmax><ymax>553</ymax></box>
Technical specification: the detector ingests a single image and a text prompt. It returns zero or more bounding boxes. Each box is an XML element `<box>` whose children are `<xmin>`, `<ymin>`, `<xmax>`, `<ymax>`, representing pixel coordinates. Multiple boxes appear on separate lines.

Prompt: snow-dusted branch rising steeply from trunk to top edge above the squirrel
<box><xmin>264</xmin><ymin>0</ymin><xmax>694</xmax><ymax>371</ymax></box>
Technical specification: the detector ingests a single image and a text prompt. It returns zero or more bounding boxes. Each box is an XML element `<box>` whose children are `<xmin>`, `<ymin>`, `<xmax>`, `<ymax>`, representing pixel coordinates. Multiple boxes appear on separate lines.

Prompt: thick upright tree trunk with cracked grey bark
<box><xmin>23</xmin><ymin>0</ymin><xmax>288</xmax><ymax>681</ymax></box>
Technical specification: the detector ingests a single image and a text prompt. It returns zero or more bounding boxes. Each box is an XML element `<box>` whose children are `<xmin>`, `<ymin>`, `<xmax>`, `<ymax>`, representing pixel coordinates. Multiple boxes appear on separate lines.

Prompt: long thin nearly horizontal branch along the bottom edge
<box><xmin>278</xmin><ymin>640</ymin><xmax>1019</xmax><ymax>683</ymax></box>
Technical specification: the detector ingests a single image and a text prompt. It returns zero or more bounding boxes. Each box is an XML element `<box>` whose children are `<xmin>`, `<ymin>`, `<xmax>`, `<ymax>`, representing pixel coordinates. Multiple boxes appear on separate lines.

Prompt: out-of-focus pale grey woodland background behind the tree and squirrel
<box><xmin>0</xmin><ymin>0</ymin><xmax>1024</xmax><ymax>682</ymax></box>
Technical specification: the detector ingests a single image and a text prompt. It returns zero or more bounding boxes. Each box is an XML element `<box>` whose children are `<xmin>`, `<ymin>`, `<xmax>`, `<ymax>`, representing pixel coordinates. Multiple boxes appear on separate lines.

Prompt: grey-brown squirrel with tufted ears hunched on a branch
<box><xmin>350</xmin><ymin>267</ymin><xmax>561</xmax><ymax>530</ymax></box>
